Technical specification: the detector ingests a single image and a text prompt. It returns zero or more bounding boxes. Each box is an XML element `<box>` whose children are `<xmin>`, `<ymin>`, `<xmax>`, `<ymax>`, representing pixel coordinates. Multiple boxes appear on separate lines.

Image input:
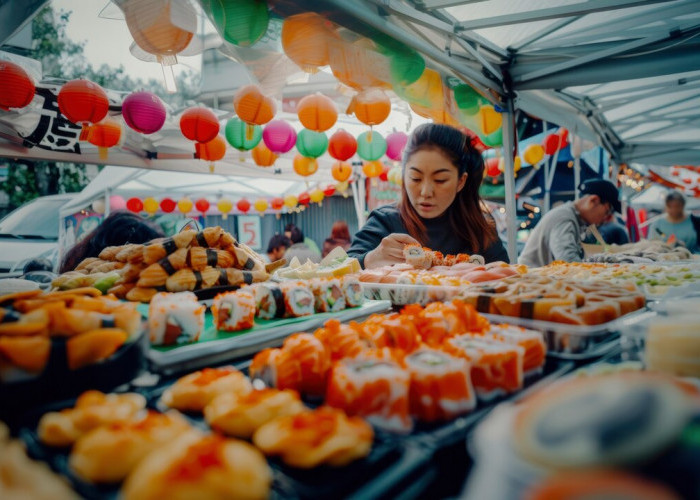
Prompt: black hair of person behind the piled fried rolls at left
<box><xmin>59</xmin><ymin>210</ymin><xmax>165</xmax><ymax>273</ymax></box>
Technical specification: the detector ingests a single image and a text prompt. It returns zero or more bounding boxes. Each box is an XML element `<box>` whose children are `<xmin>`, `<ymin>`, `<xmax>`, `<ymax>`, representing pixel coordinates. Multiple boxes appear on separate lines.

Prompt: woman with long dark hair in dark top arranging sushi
<box><xmin>348</xmin><ymin>124</ymin><xmax>508</xmax><ymax>269</ymax></box>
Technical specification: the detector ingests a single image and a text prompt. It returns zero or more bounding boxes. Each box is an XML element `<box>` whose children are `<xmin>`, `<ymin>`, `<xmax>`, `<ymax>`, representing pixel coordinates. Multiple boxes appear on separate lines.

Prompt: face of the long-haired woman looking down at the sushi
<box><xmin>403</xmin><ymin>149</ymin><xmax>467</xmax><ymax>219</ymax></box>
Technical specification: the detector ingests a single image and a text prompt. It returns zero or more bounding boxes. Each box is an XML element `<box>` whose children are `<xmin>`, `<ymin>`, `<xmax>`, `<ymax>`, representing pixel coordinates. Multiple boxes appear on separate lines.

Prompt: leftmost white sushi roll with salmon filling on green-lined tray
<box><xmin>148</xmin><ymin>292</ymin><xmax>206</xmax><ymax>345</ymax></box>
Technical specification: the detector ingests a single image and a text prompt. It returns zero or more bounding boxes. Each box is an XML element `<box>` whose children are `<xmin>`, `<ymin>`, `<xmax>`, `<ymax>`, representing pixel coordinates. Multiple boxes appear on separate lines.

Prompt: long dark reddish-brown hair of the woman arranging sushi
<box><xmin>398</xmin><ymin>123</ymin><xmax>498</xmax><ymax>252</ymax></box>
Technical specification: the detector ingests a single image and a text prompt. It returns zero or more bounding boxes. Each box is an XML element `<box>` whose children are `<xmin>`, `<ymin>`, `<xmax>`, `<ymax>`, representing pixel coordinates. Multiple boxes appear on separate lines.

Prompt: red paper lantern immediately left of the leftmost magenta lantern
<box><xmin>57</xmin><ymin>79</ymin><xmax>109</xmax><ymax>140</ymax></box>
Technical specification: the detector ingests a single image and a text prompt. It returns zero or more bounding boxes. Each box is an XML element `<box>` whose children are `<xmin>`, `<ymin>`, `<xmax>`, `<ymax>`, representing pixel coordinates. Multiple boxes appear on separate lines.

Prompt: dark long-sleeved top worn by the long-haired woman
<box><xmin>348</xmin><ymin>205</ymin><xmax>509</xmax><ymax>268</ymax></box>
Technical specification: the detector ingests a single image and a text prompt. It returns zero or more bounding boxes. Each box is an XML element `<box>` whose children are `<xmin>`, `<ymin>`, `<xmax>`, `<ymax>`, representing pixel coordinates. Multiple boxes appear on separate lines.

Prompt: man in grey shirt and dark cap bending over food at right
<box><xmin>518</xmin><ymin>179</ymin><xmax>622</xmax><ymax>267</ymax></box>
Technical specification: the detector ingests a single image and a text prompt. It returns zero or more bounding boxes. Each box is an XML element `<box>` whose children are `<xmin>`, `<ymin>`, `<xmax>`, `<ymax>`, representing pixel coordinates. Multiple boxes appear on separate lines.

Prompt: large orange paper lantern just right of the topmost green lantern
<box><xmin>282</xmin><ymin>12</ymin><xmax>338</xmax><ymax>73</ymax></box>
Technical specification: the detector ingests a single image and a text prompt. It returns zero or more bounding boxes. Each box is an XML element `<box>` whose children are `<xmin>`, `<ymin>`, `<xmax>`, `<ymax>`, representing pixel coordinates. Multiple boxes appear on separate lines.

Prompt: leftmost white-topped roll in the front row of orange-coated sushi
<box><xmin>326</xmin><ymin>355</ymin><xmax>413</xmax><ymax>433</ymax></box>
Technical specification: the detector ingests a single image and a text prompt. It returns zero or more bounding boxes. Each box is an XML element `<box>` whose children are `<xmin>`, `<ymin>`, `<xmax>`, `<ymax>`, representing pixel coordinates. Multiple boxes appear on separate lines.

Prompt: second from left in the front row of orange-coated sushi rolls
<box><xmin>405</xmin><ymin>348</ymin><xmax>476</xmax><ymax>422</ymax></box>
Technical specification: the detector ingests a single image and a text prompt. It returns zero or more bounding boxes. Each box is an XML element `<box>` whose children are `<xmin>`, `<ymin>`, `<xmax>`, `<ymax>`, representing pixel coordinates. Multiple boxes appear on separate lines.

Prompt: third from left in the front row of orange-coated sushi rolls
<box><xmin>444</xmin><ymin>333</ymin><xmax>525</xmax><ymax>401</ymax></box>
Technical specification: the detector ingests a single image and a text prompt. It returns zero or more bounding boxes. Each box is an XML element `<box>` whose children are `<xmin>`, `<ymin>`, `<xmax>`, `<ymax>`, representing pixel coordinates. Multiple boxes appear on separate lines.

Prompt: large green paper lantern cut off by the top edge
<box><xmin>202</xmin><ymin>0</ymin><xmax>270</xmax><ymax>47</ymax></box>
